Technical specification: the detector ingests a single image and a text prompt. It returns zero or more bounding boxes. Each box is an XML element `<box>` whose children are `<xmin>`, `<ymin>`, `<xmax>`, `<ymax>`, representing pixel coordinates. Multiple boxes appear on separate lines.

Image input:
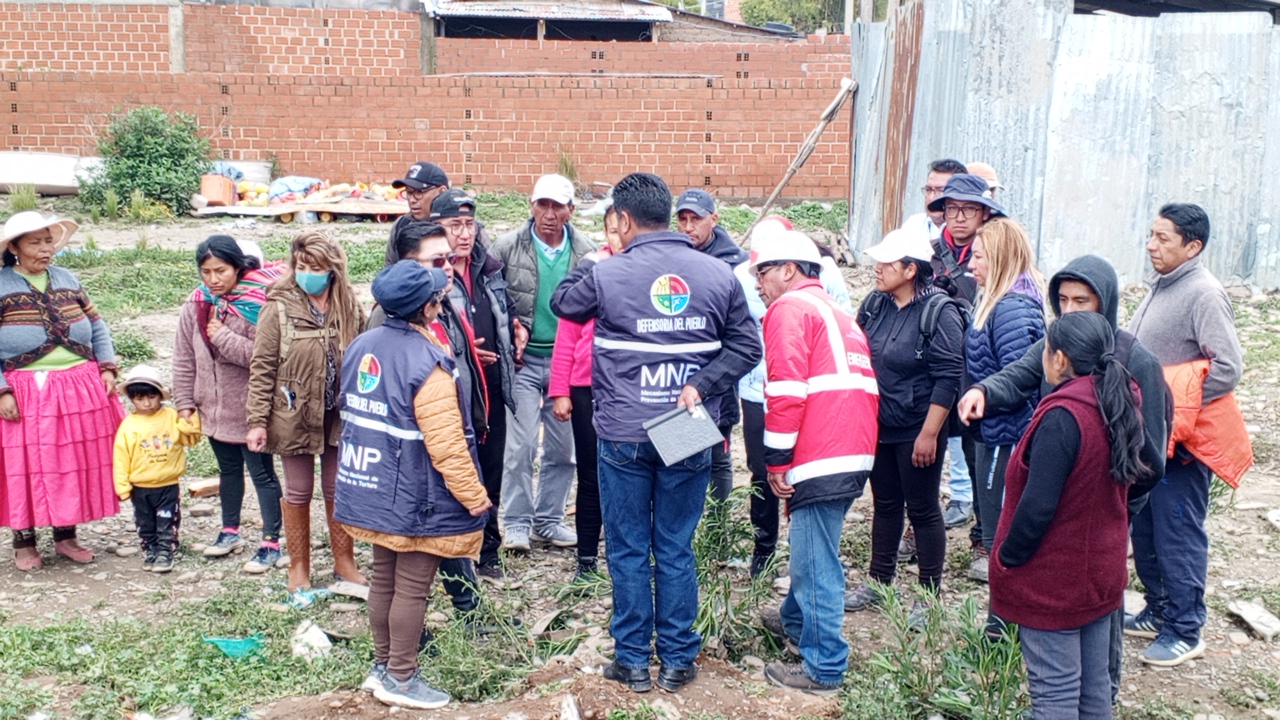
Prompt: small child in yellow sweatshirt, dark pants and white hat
<box><xmin>113</xmin><ymin>365</ymin><xmax>201</xmax><ymax>573</ymax></box>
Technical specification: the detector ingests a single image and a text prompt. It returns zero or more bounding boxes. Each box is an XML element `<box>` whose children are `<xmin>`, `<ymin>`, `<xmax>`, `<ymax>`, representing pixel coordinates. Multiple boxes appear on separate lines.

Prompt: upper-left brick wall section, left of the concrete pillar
<box><xmin>0</xmin><ymin>3</ymin><xmax>169</xmax><ymax>72</ymax></box>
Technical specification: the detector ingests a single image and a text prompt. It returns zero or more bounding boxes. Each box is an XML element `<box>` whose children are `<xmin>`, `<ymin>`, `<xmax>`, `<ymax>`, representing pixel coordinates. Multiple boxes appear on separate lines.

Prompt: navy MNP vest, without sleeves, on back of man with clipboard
<box><xmin>591</xmin><ymin>232</ymin><xmax>742</xmax><ymax>442</ymax></box>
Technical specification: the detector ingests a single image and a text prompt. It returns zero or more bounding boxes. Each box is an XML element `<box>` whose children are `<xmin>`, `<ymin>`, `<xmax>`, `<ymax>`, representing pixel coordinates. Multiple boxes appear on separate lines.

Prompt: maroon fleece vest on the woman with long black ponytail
<box><xmin>991</xmin><ymin>375</ymin><xmax>1129</xmax><ymax>630</ymax></box>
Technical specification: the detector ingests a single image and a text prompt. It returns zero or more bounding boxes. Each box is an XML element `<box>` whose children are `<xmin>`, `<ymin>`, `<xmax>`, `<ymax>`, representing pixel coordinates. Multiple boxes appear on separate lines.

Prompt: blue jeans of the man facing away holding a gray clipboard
<box><xmin>598</xmin><ymin>438</ymin><xmax>712</xmax><ymax>670</ymax></box>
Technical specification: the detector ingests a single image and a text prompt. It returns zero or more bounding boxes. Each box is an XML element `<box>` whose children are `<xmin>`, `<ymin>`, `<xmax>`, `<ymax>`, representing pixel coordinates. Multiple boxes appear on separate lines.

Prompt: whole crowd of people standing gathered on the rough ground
<box><xmin>0</xmin><ymin>152</ymin><xmax>1252</xmax><ymax>719</ymax></box>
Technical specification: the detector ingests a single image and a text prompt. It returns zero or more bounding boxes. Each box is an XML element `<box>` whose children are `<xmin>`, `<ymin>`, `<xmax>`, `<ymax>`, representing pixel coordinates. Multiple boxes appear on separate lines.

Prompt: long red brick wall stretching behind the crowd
<box><xmin>0</xmin><ymin>4</ymin><xmax>849</xmax><ymax>199</ymax></box>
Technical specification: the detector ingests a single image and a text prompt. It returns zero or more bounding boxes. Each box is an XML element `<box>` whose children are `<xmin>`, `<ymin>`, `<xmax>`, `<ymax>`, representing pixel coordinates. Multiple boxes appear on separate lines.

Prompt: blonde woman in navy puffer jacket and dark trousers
<box><xmin>964</xmin><ymin>218</ymin><xmax>1044</xmax><ymax>583</ymax></box>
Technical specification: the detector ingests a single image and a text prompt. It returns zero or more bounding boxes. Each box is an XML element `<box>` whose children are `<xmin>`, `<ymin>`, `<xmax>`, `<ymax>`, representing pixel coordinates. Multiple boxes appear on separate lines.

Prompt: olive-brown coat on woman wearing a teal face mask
<box><xmin>248</xmin><ymin>281</ymin><xmax>365</xmax><ymax>455</ymax></box>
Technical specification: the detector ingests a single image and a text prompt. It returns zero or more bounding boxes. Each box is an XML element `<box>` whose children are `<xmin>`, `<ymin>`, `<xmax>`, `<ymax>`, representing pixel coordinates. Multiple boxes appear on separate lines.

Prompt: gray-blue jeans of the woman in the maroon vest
<box><xmin>1018</xmin><ymin>612</ymin><xmax>1111</xmax><ymax>720</ymax></box>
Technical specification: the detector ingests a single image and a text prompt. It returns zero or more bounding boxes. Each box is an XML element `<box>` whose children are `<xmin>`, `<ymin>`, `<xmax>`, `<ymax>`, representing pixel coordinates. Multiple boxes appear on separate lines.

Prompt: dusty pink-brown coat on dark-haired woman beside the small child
<box><xmin>173</xmin><ymin>300</ymin><xmax>256</xmax><ymax>445</ymax></box>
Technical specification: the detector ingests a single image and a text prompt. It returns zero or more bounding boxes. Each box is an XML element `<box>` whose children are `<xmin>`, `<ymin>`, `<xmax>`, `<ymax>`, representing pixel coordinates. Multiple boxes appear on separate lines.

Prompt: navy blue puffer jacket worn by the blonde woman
<box><xmin>964</xmin><ymin>292</ymin><xmax>1044</xmax><ymax>447</ymax></box>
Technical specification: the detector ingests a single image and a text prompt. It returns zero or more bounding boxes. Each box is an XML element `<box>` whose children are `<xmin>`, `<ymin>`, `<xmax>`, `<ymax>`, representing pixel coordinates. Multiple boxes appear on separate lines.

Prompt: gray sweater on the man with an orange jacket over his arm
<box><xmin>1129</xmin><ymin>258</ymin><xmax>1244</xmax><ymax>404</ymax></box>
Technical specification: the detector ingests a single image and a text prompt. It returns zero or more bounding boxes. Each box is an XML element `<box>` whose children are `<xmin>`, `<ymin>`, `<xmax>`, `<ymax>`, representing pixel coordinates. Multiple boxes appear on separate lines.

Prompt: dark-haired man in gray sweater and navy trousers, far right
<box><xmin>1124</xmin><ymin>202</ymin><xmax>1244</xmax><ymax>666</ymax></box>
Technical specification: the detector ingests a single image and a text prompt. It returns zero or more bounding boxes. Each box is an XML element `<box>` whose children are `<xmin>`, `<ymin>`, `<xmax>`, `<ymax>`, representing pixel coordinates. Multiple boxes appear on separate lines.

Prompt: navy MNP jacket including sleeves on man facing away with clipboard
<box><xmin>552</xmin><ymin>231</ymin><xmax>762</xmax><ymax>442</ymax></box>
